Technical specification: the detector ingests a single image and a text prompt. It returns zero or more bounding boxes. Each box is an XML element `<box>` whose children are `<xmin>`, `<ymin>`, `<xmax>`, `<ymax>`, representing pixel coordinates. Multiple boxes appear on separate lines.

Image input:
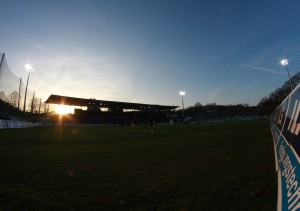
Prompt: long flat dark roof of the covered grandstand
<box><xmin>45</xmin><ymin>95</ymin><xmax>179</xmax><ymax>111</ymax></box>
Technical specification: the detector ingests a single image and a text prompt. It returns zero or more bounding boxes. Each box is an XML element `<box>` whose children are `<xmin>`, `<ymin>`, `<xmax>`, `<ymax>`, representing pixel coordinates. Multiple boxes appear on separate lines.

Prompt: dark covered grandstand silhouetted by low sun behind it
<box><xmin>45</xmin><ymin>95</ymin><xmax>179</xmax><ymax>125</ymax></box>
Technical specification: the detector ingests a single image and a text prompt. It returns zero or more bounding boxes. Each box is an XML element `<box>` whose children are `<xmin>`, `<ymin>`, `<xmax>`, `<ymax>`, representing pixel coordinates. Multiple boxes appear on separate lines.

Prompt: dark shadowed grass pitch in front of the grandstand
<box><xmin>0</xmin><ymin>121</ymin><xmax>277</xmax><ymax>210</ymax></box>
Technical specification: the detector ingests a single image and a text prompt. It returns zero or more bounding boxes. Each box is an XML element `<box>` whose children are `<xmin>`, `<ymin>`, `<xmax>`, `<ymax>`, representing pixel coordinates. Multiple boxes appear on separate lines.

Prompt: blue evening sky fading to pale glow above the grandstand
<box><xmin>0</xmin><ymin>0</ymin><xmax>300</xmax><ymax>106</ymax></box>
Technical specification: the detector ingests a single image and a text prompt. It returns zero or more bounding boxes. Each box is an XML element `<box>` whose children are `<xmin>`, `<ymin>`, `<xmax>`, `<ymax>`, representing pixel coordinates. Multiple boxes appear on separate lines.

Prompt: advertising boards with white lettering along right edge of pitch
<box><xmin>270</xmin><ymin>85</ymin><xmax>300</xmax><ymax>211</ymax></box>
